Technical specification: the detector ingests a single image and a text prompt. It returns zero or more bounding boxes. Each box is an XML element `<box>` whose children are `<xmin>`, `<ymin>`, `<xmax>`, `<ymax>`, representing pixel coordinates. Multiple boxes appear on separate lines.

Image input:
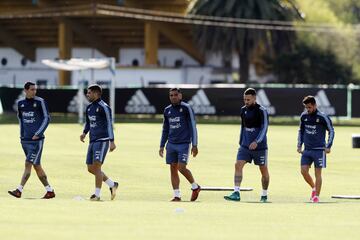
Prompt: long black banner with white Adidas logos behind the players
<box><xmin>0</xmin><ymin>87</ymin><xmax>348</xmax><ymax>117</ymax></box>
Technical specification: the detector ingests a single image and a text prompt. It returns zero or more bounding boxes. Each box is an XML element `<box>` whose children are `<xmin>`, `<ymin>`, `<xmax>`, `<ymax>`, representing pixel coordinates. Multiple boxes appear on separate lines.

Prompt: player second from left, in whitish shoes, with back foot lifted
<box><xmin>80</xmin><ymin>84</ymin><xmax>119</xmax><ymax>201</ymax></box>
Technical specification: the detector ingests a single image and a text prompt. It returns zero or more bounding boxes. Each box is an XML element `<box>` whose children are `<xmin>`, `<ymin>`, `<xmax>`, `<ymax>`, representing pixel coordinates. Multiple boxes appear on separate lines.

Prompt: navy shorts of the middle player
<box><xmin>166</xmin><ymin>143</ymin><xmax>190</xmax><ymax>164</ymax></box>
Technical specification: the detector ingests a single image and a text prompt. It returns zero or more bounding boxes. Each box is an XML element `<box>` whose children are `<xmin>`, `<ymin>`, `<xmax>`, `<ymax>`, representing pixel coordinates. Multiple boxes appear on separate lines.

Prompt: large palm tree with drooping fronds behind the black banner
<box><xmin>189</xmin><ymin>0</ymin><xmax>301</xmax><ymax>83</ymax></box>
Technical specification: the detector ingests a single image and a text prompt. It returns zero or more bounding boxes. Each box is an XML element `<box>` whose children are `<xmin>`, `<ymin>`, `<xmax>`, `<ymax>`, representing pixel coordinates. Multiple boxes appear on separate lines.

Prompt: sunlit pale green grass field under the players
<box><xmin>0</xmin><ymin>124</ymin><xmax>360</xmax><ymax>240</ymax></box>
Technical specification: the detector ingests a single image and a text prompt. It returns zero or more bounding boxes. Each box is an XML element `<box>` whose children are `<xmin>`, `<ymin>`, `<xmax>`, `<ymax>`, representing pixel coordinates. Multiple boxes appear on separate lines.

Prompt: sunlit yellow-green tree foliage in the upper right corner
<box><xmin>296</xmin><ymin>0</ymin><xmax>360</xmax><ymax>84</ymax></box>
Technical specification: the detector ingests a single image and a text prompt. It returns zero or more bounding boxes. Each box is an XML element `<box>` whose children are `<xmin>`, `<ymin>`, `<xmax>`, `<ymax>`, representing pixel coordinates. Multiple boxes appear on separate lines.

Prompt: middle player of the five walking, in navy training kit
<box><xmin>159</xmin><ymin>88</ymin><xmax>201</xmax><ymax>202</ymax></box>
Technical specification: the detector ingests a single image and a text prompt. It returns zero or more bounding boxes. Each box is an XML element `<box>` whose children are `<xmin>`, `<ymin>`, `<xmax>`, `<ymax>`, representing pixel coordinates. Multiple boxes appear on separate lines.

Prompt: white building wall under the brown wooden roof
<box><xmin>0</xmin><ymin>48</ymin><xmax>264</xmax><ymax>87</ymax></box>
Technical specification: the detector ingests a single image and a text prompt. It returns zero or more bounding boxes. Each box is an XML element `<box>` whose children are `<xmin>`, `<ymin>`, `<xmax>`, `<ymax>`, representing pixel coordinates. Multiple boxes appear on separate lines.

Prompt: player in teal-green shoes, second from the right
<box><xmin>224</xmin><ymin>88</ymin><xmax>270</xmax><ymax>202</ymax></box>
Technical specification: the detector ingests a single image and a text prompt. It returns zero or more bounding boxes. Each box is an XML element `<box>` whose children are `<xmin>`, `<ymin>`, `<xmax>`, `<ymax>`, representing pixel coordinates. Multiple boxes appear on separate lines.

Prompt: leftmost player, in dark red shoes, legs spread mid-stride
<box><xmin>8</xmin><ymin>82</ymin><xmax>55</xmax><ymax>199</ymax></box>
